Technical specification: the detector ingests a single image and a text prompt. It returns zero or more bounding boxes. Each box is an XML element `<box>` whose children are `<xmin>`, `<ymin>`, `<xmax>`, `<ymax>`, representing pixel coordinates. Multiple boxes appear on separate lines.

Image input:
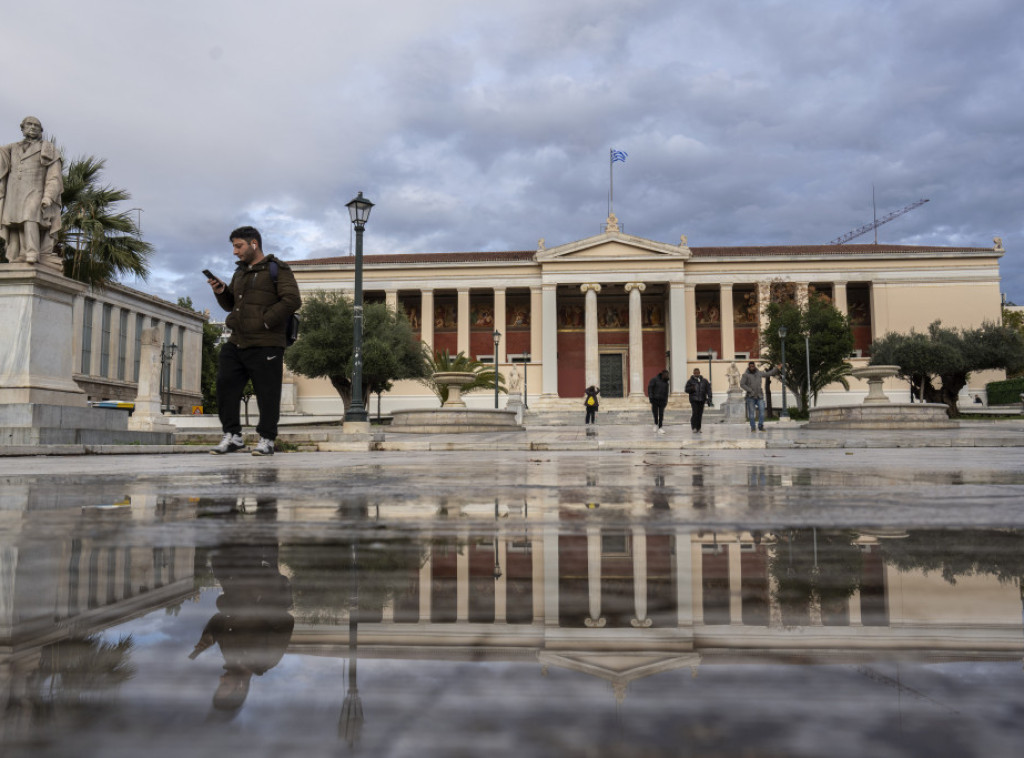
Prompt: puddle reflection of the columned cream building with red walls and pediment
<box><xmin>290</xmin><ymin>524</ymin><xmax>1022</xmax><ymax>691</ymax></box>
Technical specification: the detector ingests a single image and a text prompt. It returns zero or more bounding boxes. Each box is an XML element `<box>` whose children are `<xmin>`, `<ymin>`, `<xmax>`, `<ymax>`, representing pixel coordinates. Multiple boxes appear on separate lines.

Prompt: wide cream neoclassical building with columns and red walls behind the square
<box><xmin>292</xmin><ymin>214</ymin><xmax>1005</xmax><ymax>413</ymax></box>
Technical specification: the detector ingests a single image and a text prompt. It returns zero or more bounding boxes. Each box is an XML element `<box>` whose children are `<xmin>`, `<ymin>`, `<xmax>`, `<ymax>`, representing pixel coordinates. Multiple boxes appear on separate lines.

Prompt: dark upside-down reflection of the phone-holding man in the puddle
<box><xmin>189</xmin><ymin>503</ymin><xmax>295</xmax><ymax>715</ymax></box>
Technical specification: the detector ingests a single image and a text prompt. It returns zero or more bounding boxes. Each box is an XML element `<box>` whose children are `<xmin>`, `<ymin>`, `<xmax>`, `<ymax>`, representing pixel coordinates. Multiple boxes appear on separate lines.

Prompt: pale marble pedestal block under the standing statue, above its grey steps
<box><xmin>0</xmin><ymin>263</ymin><xmax>86</xmax><ymax>408</ymax></box>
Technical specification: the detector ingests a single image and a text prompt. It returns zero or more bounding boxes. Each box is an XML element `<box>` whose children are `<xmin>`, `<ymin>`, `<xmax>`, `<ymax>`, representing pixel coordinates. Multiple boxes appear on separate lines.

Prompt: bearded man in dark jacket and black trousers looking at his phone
<box><xmin>207</xmin><ymin>226</ymin><xmax>302</xmax><ymax>456</ymax></box>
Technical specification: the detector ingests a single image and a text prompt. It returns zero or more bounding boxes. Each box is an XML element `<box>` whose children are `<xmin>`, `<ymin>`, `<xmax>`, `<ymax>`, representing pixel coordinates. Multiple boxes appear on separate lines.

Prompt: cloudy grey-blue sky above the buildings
<box><xmin>0</xmin><ymin>0</ymin><xmax>1024</xmax><ymax>307</ymax></box>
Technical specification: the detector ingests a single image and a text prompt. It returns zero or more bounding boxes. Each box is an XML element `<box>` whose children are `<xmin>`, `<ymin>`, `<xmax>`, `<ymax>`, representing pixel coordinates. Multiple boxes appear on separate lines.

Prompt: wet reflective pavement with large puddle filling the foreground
<box><xmin>0</xmin><ymin>440</ymin><xmax>1024</xmax><ymax>758</ymax></box>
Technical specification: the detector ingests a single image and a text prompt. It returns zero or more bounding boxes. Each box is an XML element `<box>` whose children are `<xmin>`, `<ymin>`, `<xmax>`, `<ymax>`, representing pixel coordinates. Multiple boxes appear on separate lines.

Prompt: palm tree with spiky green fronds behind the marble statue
<box><xmin>57</xmin><ymin>156</ymin><xmax>153</xmax><ymax>285</ymax></box>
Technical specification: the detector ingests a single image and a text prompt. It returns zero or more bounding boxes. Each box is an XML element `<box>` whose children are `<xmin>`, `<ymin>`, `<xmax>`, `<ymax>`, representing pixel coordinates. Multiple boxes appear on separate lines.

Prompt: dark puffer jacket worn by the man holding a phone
<box><xmin>217</xmin><ymin>255</ymin><xmax>302</xmax><ymax>347</ymax></box>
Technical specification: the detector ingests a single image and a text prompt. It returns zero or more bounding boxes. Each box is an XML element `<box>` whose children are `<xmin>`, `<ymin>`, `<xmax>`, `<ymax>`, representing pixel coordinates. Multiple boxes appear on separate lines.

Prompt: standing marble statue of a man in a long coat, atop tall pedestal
<box><xmin>0</xmin><ymin>116</ymin><xmax>63</xmax><ymax>265</ymax></box>
